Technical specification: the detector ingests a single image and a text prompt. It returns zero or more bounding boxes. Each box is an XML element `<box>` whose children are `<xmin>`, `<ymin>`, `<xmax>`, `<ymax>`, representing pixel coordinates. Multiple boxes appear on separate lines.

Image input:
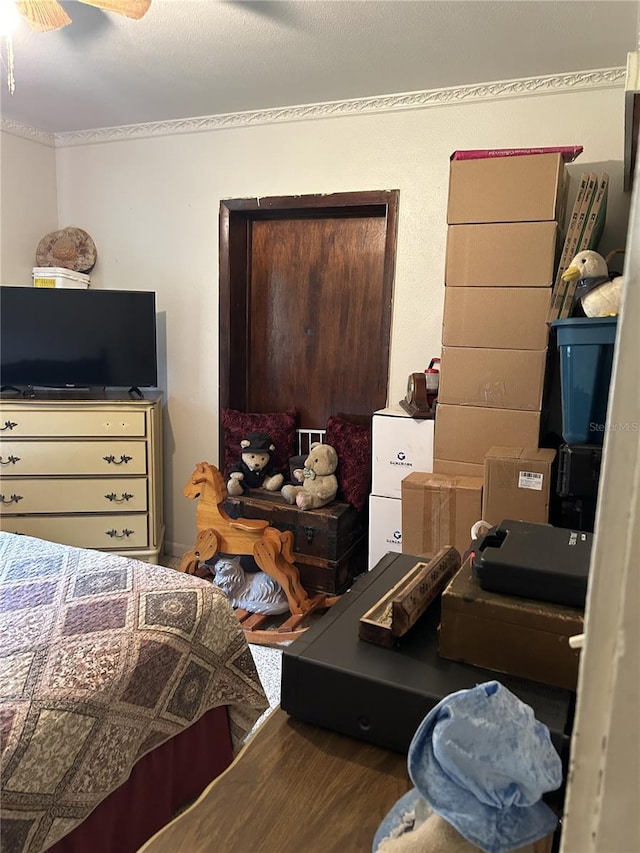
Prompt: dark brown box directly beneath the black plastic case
<box><xmin>438</xmin><ymin>560</ymin><xmax>584</xmax><ymax>691</ymax></box>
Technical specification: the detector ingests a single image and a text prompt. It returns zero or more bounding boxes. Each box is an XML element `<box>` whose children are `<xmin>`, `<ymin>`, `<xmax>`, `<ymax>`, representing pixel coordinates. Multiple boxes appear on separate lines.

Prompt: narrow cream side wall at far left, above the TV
<box><xmin>0</xmin><ymin>133</ymin><xmax>58</xmax><ymax>284</ymax></box>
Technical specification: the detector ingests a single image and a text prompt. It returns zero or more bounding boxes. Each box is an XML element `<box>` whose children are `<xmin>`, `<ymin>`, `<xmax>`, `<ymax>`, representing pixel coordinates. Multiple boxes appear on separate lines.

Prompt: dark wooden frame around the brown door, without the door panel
<box><xmin>218</xmin><ymin>190</ymin><xmax>400</xmax><ymax>440</ymax></box>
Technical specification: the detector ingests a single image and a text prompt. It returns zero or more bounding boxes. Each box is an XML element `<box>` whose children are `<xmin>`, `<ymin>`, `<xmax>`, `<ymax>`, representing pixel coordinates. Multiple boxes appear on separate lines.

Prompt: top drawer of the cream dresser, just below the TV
<box><xmin>0</xmin><ymin>405</ymin><xmax>146</xmax><ymax>438</ymax></box>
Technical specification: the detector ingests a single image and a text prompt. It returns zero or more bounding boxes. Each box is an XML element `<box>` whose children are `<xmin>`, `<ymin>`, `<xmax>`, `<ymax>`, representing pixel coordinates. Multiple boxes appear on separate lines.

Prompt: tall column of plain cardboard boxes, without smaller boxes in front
<box><xmin>434</xmin><ymin>153</ymin><xmax>567</xmax><ymax>477</ymax></box>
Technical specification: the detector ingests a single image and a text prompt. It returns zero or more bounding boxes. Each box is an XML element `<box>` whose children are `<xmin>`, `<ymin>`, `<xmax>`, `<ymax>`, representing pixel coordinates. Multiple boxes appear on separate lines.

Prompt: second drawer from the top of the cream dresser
<box><xmin>0</xmin><ymin>439</ymin><xmax>147</xmax><ymax>477</ymax></box>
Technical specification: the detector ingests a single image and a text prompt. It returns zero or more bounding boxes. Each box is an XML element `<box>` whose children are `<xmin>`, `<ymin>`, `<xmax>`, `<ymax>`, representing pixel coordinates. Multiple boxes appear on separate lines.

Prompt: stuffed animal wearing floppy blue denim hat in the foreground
<box><xmin>372</xmin><ymin>681</ymin><xmax>562</xmax><ymax>853</ymax></box>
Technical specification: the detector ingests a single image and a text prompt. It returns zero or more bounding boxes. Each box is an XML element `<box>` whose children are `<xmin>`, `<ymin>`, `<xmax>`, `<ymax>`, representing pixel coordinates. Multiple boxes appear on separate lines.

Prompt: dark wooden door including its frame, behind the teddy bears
<box><xmin>220</xmin><ymin>191</ymin><xmax>399</xmax><ymax>446</ymax></box>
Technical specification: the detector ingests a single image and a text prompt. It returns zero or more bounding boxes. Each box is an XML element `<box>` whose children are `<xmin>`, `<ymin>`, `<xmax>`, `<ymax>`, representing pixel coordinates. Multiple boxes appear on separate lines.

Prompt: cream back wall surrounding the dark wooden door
<box><xmin>1</xmin><ymin>81</ymin><xmax>629</xmax><ymax>553</ymax></box>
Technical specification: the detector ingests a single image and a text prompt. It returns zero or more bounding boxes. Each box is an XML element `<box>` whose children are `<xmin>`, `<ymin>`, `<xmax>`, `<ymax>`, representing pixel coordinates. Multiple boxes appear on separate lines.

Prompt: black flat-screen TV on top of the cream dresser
<box><xmin>0</xmin><ymin>285</ymin><xmax>157</xmax><ymax>388</ymax></box>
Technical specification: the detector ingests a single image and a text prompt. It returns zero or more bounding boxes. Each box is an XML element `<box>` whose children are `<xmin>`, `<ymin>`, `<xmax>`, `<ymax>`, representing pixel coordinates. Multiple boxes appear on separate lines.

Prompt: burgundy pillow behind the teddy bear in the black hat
<box><xmin>220</xmin><ymin>408</ymin><xmax>298</xmax><ymax>479</ymax></box>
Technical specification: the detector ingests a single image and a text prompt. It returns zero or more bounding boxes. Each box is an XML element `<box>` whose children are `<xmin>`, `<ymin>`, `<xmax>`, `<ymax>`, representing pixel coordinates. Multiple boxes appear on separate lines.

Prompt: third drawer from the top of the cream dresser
<box><xmin>0</xmin><ymin>476</ymin><xmax>148</xmax><ymax>515</ymax></box>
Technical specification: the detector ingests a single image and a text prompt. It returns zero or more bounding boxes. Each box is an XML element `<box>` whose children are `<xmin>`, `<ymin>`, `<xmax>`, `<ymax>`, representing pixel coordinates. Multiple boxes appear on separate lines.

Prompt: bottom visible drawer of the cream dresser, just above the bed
<box><xmin>0</xmin><ymin>513</ymin><xmax>149</xmax><ymax>551</ymax></box>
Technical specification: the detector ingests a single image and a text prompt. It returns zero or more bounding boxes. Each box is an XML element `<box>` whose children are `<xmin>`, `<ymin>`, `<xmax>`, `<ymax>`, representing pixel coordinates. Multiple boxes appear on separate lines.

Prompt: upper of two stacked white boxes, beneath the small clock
<box><xmin>371</xmin><ymin>406</ymin><xmax>436</xmax><ymax>498</ymax></box>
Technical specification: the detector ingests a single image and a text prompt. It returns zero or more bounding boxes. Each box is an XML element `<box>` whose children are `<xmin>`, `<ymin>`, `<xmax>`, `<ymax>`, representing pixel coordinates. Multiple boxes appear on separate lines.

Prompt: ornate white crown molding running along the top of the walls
<box><xmin>1</xmin><ymin>68</ymin><xmax>626</xmax><ymax>147</ymax></box>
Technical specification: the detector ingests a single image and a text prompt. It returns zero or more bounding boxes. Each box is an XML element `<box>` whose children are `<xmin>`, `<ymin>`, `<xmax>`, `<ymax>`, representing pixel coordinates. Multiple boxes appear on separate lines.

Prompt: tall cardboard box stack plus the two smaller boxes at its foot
<box><xmin>402</xmin><ymin>153</ymin><xmax>568</xmax><ymax>556</ymax></box>
